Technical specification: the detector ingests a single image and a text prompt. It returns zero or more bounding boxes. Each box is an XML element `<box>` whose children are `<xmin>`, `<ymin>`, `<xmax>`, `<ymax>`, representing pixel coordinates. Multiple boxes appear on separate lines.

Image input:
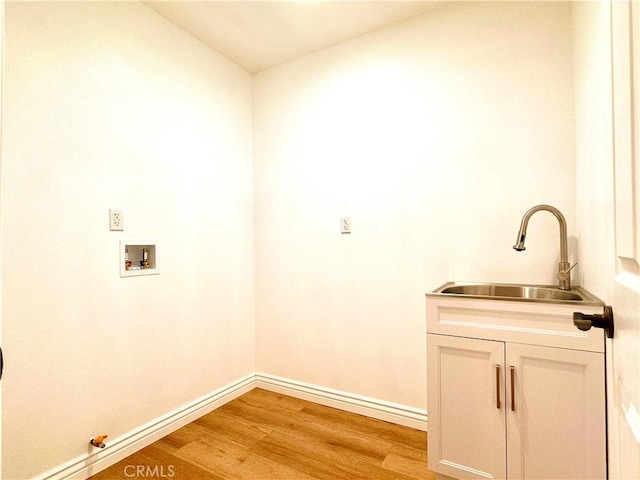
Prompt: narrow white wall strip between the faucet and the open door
<box><xmin>573</xmin><ymin>2</ymin><xmax>616</xmax><ymax>299</ymax></box>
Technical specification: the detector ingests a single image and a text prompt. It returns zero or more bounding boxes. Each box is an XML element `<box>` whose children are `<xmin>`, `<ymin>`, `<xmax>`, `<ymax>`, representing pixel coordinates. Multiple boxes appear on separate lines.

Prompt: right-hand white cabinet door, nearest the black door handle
<box><xmin>507</xmin><ymin>343</ymin><xmax>606</xmax><ymax>480</ymax></box>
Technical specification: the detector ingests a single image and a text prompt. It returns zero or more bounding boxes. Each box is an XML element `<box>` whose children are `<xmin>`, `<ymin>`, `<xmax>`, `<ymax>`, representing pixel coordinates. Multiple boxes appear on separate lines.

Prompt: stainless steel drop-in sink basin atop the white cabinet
<box><xmin>430</xmin><ymin>282</ymin><xmax>604</xmax><ymax>305</ymax></box>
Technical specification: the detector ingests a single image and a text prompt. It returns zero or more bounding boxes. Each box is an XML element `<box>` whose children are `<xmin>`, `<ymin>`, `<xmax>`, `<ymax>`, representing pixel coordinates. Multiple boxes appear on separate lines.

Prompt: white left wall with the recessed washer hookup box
<box><xmin>2</xmin><ymin>2</ymin><xmax>255</xmax><ymax>479</ymax></box>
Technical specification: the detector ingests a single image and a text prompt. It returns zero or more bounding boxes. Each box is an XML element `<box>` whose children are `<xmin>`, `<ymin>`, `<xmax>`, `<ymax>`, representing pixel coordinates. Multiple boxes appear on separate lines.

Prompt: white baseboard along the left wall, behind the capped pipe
<box><xmin>37</xmin><ymin>374</ymin><xmax>256</xmax><ymax>480</ymax></box>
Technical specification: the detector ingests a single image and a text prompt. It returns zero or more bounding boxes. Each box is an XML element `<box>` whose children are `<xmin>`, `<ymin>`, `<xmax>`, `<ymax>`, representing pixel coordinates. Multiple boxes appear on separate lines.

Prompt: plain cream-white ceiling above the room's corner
<box><xmin>142</xmin><ymin>0</ymin><xmax>448</xmax><ymax>73</ymax></box>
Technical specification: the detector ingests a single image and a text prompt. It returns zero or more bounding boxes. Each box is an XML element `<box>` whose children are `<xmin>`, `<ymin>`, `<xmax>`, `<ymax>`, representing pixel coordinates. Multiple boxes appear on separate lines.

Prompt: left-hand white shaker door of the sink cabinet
<box><xmin>427</xmin><ymin>334</ymin><xmax>506</xmax><ymax>480</ymax></box>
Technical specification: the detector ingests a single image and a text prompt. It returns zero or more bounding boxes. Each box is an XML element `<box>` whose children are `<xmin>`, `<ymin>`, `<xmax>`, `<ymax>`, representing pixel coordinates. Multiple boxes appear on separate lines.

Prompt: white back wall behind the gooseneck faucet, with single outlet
<box><xmin>254</xmin><ymin>2</ymin><xmax>577</xmax><ymax>408</ymax></box>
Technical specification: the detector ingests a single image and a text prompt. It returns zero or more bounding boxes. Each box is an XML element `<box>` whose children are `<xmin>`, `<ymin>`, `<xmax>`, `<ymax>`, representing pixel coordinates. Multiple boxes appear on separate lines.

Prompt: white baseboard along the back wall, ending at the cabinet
<box><xmin>256</xmin><ymin>373</ymin><xmax>427</xmax><ymax>432</ymax></box>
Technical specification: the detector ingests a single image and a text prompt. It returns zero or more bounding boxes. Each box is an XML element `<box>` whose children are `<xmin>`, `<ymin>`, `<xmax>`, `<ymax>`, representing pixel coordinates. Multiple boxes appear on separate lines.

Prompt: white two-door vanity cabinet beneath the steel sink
<box><xmin>427</xmin><ymin>295</ymin><xmax>606</xmax><ymax>480</ymax></box>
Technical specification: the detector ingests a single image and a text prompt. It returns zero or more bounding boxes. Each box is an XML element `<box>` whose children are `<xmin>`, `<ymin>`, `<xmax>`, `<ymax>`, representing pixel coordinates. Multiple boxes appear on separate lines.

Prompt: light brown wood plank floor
<box><xmin>92</xmin><ymin>389</ymin><xmax>435</xmax><ymax>480</ymax></box>
